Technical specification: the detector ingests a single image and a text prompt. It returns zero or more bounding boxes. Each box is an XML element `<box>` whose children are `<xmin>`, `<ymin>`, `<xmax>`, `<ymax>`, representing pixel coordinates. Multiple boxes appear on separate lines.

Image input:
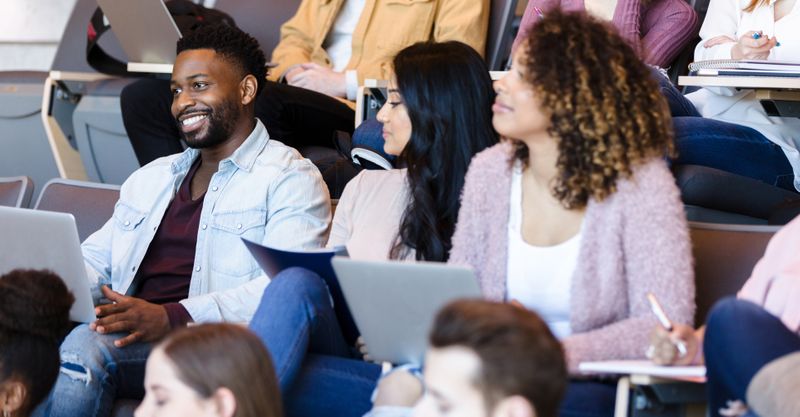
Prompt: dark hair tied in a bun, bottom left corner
<box><xmin>0</xmin><ymin>270</ymin><xmax>74</xmax><ymax>415</ymax></box>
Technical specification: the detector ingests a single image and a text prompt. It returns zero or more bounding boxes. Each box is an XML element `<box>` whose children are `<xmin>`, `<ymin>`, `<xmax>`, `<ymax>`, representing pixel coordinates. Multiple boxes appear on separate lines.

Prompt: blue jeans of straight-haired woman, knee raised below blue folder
<box><xmin>250</xmin><ymin>268</ymin><xmax>380</xmax><ymax>417</ymax></box>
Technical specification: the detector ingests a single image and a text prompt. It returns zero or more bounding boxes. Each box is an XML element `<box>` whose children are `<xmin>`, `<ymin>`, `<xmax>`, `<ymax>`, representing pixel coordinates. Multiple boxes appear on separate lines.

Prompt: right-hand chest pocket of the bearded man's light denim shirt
<box><xmin>209</xmin><ymin>207</ymin><xmax>267</xmax><ymax>278</ymax></box>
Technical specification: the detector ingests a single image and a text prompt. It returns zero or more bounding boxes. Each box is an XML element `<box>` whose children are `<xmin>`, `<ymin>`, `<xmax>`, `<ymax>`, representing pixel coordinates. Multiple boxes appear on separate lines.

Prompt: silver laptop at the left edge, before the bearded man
<box><xmin>0</xmin><ymin>207</ymin><xmax>95</xmax><ymax>323</ymax></box>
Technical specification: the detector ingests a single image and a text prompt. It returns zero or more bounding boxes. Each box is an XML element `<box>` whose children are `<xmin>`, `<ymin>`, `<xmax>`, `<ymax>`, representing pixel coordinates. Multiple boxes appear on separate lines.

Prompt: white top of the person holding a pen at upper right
<box><xmin>686</xmin><ymin>0</ymin><xmax>800</xmax><ymax>190</ymax></box>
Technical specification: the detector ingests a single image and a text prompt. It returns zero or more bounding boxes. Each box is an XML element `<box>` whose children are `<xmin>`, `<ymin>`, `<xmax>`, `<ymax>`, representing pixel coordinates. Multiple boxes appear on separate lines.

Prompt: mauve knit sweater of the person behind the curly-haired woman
<box><xmin>514</xmin><ymin>0</ymin><xmax>700</xmax><ymax>68</ymax></box>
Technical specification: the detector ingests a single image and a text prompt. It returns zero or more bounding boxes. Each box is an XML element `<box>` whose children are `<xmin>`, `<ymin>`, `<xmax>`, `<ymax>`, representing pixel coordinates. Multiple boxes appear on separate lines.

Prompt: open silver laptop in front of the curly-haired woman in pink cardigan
<box><xmin>331</xmin><ymin>257</ymin><xmax>481</xmax><ymax>365</ymax></box>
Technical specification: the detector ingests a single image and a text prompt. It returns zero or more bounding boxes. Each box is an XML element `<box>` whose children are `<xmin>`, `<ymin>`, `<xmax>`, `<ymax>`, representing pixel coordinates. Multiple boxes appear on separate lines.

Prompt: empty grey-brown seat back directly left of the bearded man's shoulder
<box><xmin>33</xmin><ymin>178</ymin><xmax>119</xmax><ymax>241</ymax></box>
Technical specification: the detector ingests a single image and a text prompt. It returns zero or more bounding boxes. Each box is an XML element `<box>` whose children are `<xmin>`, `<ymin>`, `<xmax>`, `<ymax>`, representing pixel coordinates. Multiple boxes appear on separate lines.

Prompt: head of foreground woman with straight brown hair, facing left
<box><xmin>135</xmin><ymin>324</ymin><xmax>283</xmax><ymax>417</ymax></box>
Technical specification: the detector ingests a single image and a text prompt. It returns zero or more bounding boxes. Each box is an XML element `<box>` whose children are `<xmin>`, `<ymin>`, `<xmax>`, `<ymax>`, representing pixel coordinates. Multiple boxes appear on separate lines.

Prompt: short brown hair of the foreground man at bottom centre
<box><xmin>430</xmin><ymin>300</ymin><xmax>568</xmax><ymax>417</ymax></box>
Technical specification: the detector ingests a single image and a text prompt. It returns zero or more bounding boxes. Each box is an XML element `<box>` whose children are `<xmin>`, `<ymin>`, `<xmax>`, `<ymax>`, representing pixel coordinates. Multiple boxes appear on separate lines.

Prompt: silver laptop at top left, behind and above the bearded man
<box><xmin>97</xmin><ymin>0</ymin><xmax>181</xmax><ymax>64</ymax></box>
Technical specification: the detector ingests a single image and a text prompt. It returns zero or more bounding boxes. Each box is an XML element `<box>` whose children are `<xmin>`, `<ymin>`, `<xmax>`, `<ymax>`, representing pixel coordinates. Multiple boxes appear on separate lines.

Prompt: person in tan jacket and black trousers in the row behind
<box><xmin>120</xmin><ymin>0</ymin><xmax>490</xmax><ymax>165</ymax></box>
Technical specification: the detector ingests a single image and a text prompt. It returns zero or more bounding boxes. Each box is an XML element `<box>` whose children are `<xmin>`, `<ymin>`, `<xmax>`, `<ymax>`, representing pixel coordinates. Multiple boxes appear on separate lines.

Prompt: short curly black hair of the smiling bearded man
<box><xmin>177</xmin><ymin>23</ymin><xmax>267</xmax><ymax>94</ymax></box>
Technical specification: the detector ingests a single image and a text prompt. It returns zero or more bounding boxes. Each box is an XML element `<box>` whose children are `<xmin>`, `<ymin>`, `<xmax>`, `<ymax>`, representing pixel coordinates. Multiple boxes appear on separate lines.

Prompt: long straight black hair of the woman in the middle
<box><xmin>389</xmin><ymin>41</ymin><xmax>498</xmax><ymax>262</ymax></box>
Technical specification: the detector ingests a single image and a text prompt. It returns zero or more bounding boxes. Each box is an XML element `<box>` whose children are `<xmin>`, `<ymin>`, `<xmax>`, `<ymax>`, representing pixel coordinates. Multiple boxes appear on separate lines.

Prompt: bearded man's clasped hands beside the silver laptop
<box><xmin>89</xmin><ymin>285</ymin><xmax>170</xmax><ymax>347</ymax></box>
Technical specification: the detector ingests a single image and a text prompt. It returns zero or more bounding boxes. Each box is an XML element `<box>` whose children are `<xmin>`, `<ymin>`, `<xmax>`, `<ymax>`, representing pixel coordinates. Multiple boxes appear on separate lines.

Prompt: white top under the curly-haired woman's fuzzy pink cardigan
<box><xmin>506</xmin><ymin>165</ymin><xmax>581</xmax><ymax>339</ymax></box>
